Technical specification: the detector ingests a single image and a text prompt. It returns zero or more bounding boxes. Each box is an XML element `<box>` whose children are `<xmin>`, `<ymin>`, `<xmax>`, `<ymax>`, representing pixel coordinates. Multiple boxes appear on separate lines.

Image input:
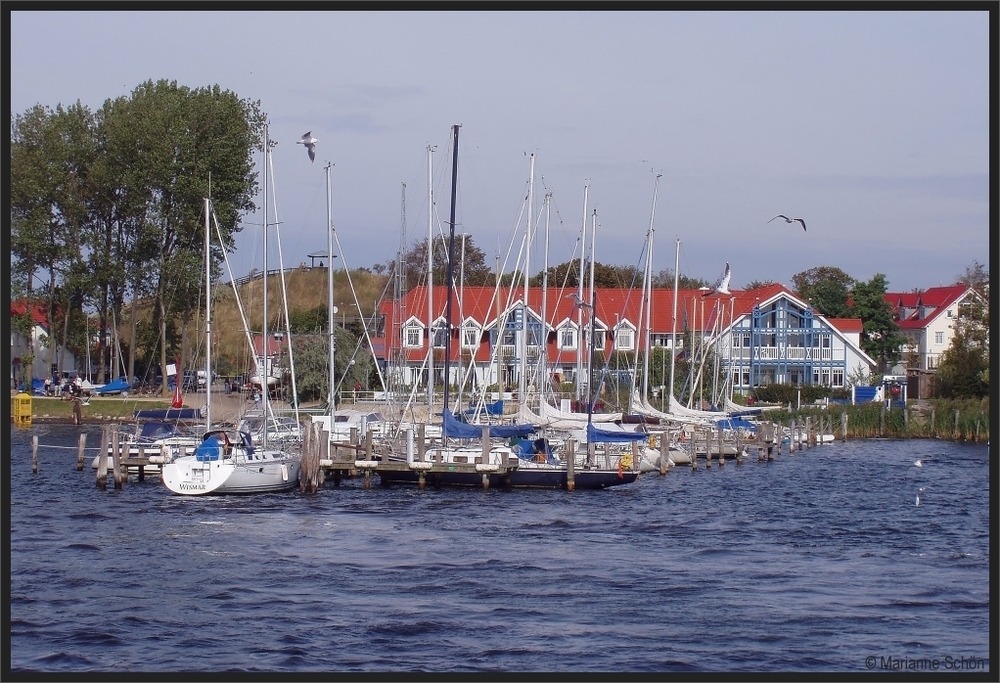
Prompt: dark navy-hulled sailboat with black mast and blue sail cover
<box><xmin>379</xmin><ymin>132</ymin><xmax>644</xmax><ymax>489</ymax></box>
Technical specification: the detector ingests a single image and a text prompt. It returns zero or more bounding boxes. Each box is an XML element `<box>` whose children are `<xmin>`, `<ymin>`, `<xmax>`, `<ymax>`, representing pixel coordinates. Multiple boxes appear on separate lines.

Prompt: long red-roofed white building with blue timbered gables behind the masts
<box><xmin>374</xmin><ymin>284</ymin><xmax>876</xmax><ymax>394</ymax></box>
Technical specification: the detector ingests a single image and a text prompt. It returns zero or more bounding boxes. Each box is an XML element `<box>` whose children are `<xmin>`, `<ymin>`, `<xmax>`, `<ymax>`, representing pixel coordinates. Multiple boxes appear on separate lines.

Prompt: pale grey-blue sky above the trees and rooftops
<box><xmin>9</xmin><ymin>5</ymin><xmax>991</xmax><ymax>292</ymax></box>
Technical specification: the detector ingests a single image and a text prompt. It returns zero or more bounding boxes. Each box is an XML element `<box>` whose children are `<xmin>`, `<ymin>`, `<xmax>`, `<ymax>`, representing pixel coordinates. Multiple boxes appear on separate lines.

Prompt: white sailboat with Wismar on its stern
<box><xmin>161</xmin><ymin>139</ymin><xmax>302</xmax><ymax>496</ymax></box>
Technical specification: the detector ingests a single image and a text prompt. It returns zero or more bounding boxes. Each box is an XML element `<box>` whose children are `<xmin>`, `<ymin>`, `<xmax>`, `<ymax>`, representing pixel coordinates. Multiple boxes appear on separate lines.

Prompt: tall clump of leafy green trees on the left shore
<box><xmin>11</xmin><ymin>80</ymin><xmax>264</xmax><ymax>379</ymax></box>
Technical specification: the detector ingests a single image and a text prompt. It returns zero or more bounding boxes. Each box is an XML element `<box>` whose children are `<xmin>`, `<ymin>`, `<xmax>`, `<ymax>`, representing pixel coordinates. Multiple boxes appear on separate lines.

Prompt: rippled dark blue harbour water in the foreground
<box><xmin>9</xmin><ymin>425</ymin><xmax>990</xmax><ymax>672</ymax></box>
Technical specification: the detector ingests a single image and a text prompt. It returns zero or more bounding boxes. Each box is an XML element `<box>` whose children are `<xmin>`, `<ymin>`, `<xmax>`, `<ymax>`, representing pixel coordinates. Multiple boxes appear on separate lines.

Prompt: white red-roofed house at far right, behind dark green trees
<box><xmin>885</xmin><ymin>284</ymin><xmax>985</xmax><ymax>372</ymax></box>
